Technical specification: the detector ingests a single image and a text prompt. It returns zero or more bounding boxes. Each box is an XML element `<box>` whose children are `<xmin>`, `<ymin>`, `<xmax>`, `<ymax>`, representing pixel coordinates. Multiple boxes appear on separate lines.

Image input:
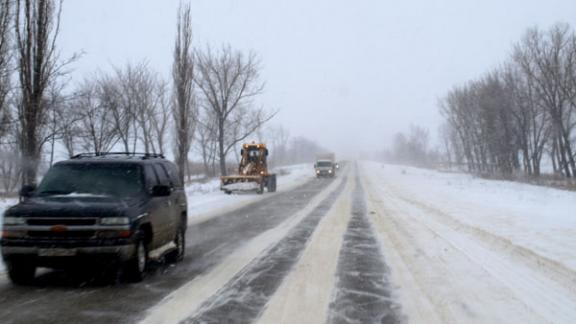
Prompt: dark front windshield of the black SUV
<box><xmin>37</xmin><ymin>163</ymin><xmax>144</xmax><ymax>197</ymax></box>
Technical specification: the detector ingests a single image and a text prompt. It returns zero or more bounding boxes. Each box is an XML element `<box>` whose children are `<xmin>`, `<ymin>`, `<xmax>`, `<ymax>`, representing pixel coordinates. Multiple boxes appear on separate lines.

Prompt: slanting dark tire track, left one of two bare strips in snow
<box><xmin>181</xmin><ymin>177</ymin><xmax>346</xmax><ymax>323</ymax></box>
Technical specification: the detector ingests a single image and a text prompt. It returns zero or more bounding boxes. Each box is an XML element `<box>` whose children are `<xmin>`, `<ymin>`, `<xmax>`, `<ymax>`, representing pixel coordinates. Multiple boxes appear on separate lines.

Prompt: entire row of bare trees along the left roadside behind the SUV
<box><xmin>0</xmin><ymin>0</ymin><xmax>304</xmax><ymax>192</ymax></box>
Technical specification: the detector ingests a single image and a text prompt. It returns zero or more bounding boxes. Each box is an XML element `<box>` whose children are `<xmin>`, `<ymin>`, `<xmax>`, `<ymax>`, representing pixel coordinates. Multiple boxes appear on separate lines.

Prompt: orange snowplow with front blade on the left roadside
<box><xmin>220</xmin><ymin>143</ymin><xmax>276</xmax><ymax>194</ymax></box>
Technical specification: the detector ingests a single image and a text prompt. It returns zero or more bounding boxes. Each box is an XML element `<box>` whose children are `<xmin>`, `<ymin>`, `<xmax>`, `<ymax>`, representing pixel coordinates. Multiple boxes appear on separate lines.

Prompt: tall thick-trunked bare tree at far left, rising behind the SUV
<box><xmin>15</xmin><ymin>0</ymin><xmax>67</xmax><ymax>184</ymax></box>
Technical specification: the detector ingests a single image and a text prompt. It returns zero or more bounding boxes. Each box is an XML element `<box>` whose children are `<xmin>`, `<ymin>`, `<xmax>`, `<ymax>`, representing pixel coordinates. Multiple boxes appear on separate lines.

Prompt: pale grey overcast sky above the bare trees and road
<box><xmin>59</xmin><ymin>0</ymin><xmax>576</xmax><ymax>156</ymax></box>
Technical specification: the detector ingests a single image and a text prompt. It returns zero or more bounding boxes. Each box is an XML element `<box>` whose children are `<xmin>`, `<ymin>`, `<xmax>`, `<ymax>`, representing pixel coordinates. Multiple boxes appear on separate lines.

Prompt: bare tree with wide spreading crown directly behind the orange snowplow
<box><xmin>195</xmin><ymin>46</ymin><xmax>274</xmax><ymax>175</ymax></box>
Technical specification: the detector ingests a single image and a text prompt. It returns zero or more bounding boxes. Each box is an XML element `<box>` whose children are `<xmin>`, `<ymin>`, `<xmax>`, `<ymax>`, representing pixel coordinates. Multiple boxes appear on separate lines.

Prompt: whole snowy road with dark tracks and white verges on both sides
<box><xmin>0</xmin><ymin>162</ymin><xmax>576</xmax><ymax>323</ymax></box>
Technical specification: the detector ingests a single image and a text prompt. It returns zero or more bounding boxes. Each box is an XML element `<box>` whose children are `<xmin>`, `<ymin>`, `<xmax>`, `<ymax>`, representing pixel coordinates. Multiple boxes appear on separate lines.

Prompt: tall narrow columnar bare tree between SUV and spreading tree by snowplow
<box><xmin>172</xmin><ymin>4</ymin><xmax>198</xmax><ymax>178</ymax></box>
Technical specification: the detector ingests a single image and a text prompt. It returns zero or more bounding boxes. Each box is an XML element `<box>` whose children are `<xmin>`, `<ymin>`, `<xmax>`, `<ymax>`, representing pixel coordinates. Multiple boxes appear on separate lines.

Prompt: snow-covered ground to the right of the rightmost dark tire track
<box><xmin>361</xmin><ymin>163</ymin><xmax>576</xmax><ymax>323</ymax></box>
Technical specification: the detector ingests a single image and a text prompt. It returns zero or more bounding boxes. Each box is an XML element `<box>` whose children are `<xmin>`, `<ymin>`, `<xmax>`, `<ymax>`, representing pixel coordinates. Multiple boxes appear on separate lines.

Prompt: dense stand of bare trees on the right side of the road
<box><xmin>439</xmin><ymin>24</ymin><xmax>576</xmax><ymax>178</ymax></box>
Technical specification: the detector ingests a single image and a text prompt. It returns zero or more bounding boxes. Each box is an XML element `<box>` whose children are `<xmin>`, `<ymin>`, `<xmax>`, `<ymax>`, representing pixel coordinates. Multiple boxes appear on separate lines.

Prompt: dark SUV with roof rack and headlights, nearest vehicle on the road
<box><xmin>1</xmin><ymin>153</ymin><xmax>187</xmax><ymax>284</ymax></box>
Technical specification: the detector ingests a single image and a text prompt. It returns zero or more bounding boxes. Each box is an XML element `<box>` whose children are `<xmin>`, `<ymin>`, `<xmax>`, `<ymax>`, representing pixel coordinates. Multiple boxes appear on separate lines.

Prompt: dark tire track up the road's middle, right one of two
<box><xmin>328</xmin><ymin>176</ymin><xmax>403</xmax><ymax>323</ymax></box>
